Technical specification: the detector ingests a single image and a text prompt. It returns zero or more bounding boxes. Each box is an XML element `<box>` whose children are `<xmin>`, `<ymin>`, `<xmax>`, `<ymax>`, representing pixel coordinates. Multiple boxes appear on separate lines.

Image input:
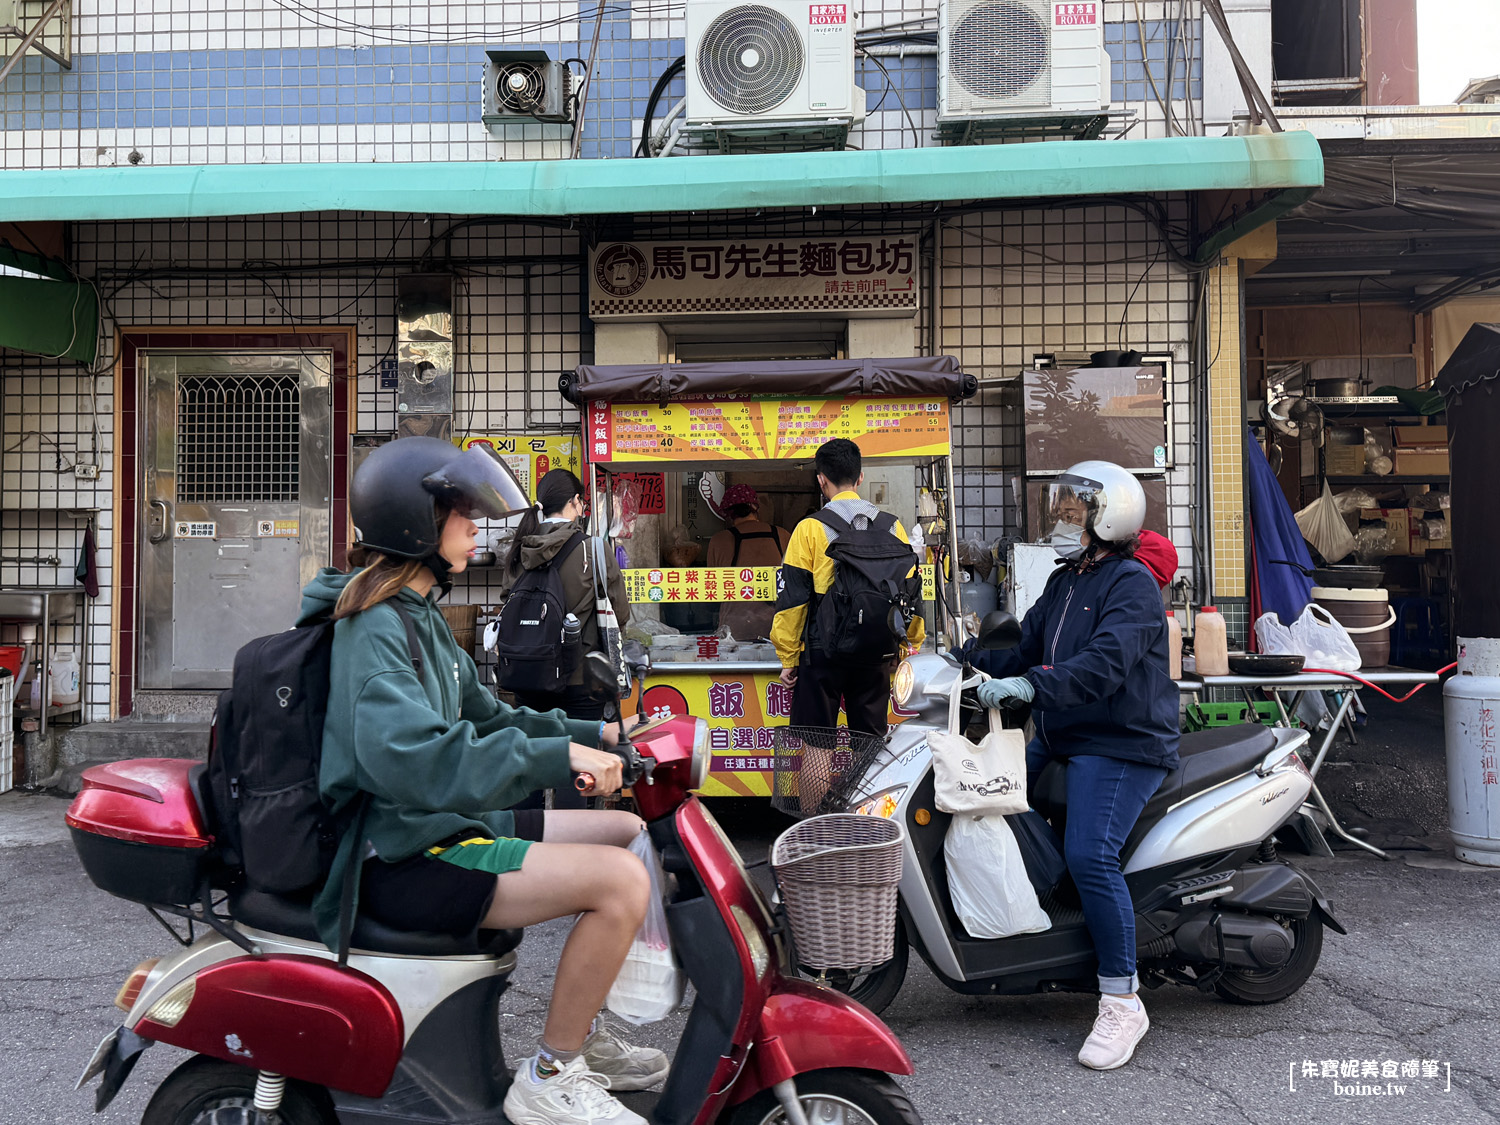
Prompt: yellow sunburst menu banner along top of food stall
<box><xmin>588</xmin><ymin>398</ymin><xmax>950</xmax><ymax>464</ymax></box>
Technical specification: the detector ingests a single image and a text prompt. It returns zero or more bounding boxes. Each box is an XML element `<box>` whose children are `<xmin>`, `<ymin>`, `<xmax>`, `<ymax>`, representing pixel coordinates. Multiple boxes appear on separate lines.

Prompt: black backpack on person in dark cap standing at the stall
<box><xmin>495</xmin><ymin>531</ymin><xmax>584</xmax><ymax>692</ymax></box>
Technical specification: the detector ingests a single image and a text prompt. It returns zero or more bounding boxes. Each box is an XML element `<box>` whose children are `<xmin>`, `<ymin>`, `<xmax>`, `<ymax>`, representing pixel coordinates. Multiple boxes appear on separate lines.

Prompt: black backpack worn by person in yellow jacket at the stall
<box><xmin>810</xmin><ymin>509</ymin><xmax>921</xmax><ymax>665</ymax></box>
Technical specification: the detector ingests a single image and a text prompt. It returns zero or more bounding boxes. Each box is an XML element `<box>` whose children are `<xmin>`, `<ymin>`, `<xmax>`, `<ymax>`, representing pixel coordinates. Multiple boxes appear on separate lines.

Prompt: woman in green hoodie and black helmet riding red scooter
<box><xmin>303</xmin><ymin>438</ymin><xmax>668</xmax><ymax>1125</ymax></box>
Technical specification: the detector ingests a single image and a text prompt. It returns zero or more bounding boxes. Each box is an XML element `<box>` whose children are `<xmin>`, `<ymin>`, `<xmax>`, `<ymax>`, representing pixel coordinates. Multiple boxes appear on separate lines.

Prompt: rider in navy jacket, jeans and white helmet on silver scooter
<box><xmin>969</xmin><ymin>461</ymin><xmax>1179</xmax><ymax>1070</ymax></box>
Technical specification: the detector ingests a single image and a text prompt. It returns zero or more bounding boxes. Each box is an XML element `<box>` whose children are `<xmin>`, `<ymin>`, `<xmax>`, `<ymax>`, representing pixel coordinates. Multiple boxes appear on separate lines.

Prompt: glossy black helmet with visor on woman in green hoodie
<box><xmin>350</xmin><ymin>437</ymin><xmax>528</xmax><ymax>560</ymax></box>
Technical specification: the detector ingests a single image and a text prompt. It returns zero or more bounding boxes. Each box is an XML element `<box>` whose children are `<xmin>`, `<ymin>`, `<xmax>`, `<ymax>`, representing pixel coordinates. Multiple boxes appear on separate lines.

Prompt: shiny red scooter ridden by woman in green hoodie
<box><xmin>68</xmin><ymin>708</ymin><xmax>921</xmax><ymax>1125</ymax></box>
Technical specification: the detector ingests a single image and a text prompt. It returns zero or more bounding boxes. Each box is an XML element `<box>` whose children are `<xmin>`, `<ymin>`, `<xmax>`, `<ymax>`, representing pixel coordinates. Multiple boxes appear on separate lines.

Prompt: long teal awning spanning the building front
<box><xmin>0</xmin><ymin>132</ymin><xmax>1323</xmax><ymax>229</ymax></box>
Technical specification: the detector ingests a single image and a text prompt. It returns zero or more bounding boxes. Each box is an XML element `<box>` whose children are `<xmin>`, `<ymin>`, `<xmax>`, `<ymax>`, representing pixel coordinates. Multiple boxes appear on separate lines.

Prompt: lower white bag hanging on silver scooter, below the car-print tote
<box><xmin>942</xmin><ymin>816</ymin><xmax>1052</xmax><ymax>938</ymax></box>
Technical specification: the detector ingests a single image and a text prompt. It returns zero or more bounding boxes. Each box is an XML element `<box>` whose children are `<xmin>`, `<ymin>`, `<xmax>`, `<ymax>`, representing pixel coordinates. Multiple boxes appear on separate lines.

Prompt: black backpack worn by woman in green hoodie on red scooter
<box><xmin>207</xmin><ymin>599</ymin><xmax>422</xmax><ymax>894</ymax></box>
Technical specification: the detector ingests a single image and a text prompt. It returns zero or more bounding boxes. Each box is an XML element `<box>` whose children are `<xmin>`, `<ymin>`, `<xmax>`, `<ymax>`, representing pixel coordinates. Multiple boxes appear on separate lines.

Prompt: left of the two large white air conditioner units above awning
<box><xmin>686</xmin><ymin>0</ymin><xmax>864</xmax><ymax>129</ymax></box>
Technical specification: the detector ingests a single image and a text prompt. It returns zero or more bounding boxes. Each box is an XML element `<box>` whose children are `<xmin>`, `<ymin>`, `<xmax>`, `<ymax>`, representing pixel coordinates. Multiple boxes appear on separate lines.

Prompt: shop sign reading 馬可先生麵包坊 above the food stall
<box><xmin>588</xmin><ymin>237</ymin><xmax>921</xmax><ymax>320</ymax></box>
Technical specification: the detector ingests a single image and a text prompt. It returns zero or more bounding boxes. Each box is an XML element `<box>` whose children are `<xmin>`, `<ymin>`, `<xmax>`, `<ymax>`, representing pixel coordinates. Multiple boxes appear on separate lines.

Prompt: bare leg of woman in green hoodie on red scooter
<box><xmin>480</xmin><ymin>840</ymin><xmax>651</xmax><ymax>1052</ymax></box>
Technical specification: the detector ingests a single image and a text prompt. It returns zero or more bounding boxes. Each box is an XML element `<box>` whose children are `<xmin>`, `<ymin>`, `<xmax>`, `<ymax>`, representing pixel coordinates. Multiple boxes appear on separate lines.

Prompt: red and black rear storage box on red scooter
<box><xmin>66</xmin><ymin>758</ymin><xmax>215</xmax><ymax>906</ymax></box>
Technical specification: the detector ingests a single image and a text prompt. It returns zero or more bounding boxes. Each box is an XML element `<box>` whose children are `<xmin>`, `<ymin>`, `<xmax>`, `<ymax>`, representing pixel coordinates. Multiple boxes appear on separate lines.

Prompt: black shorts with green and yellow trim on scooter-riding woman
<box><xmin>360</xmin><ymin>810</ymin><xmax>546</xmax><ymax>942</ymax></box>
